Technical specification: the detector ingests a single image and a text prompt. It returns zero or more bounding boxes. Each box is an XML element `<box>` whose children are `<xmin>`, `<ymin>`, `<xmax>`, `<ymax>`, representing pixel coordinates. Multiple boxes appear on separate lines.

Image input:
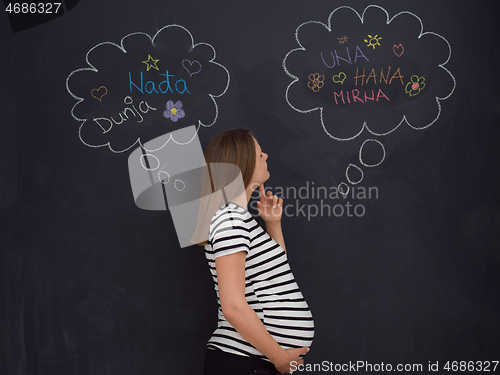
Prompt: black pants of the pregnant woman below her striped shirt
<box><xmin>203</xmin><ymin>349</ymin><xmax>278</xmax><ymax>375</ymax></box>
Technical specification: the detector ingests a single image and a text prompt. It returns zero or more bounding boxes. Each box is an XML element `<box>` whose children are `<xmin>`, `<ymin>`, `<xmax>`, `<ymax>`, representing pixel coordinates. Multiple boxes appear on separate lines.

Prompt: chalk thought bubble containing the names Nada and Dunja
<box><xmin>66</xmin><ymin>25</ymin><xmax>230</xmax><ymax>153</ymax></box>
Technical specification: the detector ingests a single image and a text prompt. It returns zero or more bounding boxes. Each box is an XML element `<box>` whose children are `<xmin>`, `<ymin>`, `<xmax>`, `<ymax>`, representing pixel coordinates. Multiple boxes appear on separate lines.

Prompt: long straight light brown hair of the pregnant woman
<box><xmin>191</xmin><ymin>129</ymin><xmax>257</xmax><ymax>246</ymax></box>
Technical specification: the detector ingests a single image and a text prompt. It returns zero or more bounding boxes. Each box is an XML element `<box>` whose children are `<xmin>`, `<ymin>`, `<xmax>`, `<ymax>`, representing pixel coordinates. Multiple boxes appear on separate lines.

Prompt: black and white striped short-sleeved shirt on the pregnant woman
<box><xmin>205</xmin><ymin>202</ymin><xmax>314</xmax><ymax>359</ymax></box>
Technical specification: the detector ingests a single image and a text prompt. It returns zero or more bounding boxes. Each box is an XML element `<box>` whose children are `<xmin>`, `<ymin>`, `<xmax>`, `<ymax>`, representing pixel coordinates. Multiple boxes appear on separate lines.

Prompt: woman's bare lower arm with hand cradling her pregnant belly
<box><xmin>215</xmin><ymin>251</ymin><xmax>309</xmax><ymax>373</ymax></box>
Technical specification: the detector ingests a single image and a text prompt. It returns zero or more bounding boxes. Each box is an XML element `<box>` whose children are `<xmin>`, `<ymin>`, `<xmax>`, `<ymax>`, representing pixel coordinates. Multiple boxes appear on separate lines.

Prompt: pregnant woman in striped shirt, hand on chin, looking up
<box><xmin>195</xmin><ymin>129</ymin><xmax>314</xmax><ymax>375</ymax></box>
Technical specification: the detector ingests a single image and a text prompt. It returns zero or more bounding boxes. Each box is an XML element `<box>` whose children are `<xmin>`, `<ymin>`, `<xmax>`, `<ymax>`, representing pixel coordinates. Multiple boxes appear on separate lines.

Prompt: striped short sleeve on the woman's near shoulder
<box><xmin>210</xmin><ymin>211</ymin><xmax>250</xmax><ymax>258</ymax></box>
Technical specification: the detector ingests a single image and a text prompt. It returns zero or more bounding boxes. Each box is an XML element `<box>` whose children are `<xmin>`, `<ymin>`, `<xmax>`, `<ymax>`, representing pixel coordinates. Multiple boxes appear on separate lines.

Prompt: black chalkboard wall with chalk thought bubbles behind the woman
<box><xmin>0</xmin><ymin>0</ymin><xmax>500</xmax><ymax>375</ymax></box>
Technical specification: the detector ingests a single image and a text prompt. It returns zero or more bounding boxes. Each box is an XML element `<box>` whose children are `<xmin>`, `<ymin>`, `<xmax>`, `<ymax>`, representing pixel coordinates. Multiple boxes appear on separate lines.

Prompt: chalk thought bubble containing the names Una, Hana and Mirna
<box><xmin>283</xmin><ymin>5</ymin><xmax>456</xmax><ymax>141</ymax></box>
